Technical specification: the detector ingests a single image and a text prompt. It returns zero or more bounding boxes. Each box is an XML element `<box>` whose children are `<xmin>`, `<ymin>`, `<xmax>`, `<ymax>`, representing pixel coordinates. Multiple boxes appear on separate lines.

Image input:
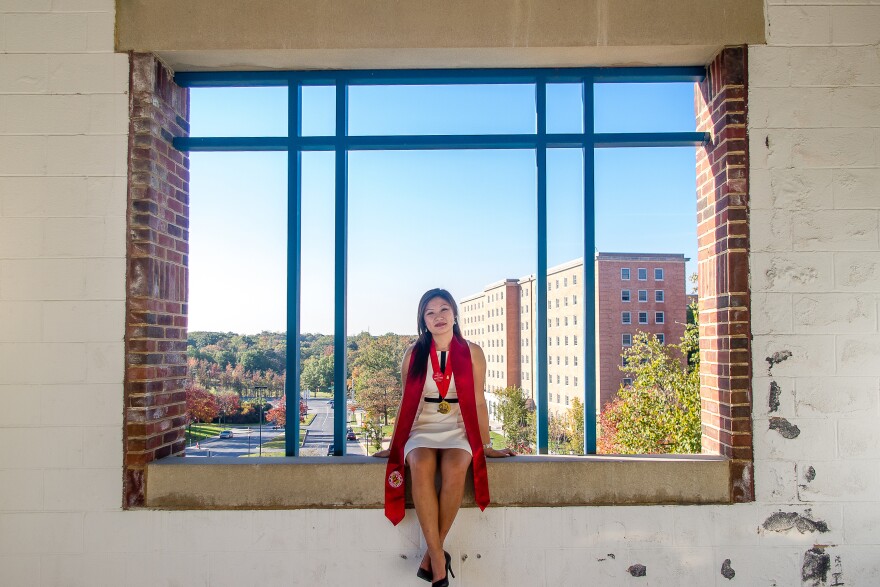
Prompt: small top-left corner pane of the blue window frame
<box><xmin>190</xmin><ymin>87</ymin><xmax>287</xmax><ymax>137</ymax></box>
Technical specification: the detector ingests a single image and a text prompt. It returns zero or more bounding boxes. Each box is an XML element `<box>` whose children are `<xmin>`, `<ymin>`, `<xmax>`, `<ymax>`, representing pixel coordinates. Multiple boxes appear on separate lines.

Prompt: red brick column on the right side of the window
<box><xmin>695</xmin><ymin>47</ymin><xmax>754</xmax><ymax>502</ymax></box>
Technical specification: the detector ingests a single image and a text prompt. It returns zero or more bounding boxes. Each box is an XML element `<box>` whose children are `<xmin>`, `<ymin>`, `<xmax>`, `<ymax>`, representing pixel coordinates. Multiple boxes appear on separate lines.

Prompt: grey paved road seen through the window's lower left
<box><xmin>186</xmin><ymin>399</ymin><xmax>367</xmax><ymax>457</ymax></box>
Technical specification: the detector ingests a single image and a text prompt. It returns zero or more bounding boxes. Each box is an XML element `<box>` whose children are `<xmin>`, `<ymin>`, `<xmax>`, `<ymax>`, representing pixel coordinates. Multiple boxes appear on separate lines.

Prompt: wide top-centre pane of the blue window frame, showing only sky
<box><xmin>348</xmin><ymin>84</ymin><xmax>535</xmax><ymax>136</ymax></box>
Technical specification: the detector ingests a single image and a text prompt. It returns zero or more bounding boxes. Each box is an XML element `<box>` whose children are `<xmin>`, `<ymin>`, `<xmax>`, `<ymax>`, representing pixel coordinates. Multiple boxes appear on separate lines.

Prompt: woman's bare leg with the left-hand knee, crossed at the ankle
<box><xmin>406</xmin><ymin>448</ymin><xmax>446</xmax><ymax>580</ymax></box>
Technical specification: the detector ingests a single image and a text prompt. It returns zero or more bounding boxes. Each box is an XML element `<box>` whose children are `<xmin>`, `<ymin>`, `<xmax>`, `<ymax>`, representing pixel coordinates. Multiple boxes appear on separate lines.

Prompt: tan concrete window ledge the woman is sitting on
<box><xmin>145</xmin><ymin>455</ymin><xmax>733</xmax><ymax>509</ymax></box>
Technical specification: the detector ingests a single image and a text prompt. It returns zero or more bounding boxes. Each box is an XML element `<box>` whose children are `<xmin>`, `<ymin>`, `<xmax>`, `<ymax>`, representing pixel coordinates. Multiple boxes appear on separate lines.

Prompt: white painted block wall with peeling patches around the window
<box><xmin>0</xmin><ymin>0</ymin><xmax>880</xmax><ymax>587</ymax></box>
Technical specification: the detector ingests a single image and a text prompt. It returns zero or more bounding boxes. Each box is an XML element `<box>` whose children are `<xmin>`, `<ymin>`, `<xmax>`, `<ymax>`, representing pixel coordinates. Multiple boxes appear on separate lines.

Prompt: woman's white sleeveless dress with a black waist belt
<box><xmin>403</xmin><ymin>358</ymin><xmax>471</xmax><ymax>462</ymax></box>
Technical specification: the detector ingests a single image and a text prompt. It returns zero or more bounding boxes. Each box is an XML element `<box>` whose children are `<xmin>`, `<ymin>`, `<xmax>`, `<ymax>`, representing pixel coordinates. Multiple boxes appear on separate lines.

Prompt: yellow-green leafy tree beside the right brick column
<box><xmin>600</xmin><ymin>312</ymin><xmax>701</xmax><ymax>454</ymax></box>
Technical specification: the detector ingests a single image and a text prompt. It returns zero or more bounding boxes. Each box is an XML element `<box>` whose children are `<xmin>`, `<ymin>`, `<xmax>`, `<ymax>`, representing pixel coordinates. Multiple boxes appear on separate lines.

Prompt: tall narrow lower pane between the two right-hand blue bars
<box><xmin>547</xmin><ymin>149</ymin><xmax>584</xmax><ymax>454</ymax></box>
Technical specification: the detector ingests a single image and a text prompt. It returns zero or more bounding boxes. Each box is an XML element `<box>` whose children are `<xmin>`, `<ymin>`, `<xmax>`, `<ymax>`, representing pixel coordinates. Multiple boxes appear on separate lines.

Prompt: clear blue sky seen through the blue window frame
<box><xmin>189</xmin><ymin>84</ymin><xmax>696</xmax><ymax>334</ymax></box>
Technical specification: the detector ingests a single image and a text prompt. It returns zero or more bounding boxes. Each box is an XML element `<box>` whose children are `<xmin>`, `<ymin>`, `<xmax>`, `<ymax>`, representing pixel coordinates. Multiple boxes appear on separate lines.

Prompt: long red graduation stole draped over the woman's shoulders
<box><xmin>385</xmin><ymin>337</ymin><xmax>489</xmax><ymax>526</ymax></box>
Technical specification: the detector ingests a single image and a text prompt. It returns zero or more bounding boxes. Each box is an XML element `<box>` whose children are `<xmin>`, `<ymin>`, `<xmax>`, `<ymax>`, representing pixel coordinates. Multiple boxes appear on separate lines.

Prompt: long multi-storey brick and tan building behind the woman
<box><xmin>459</xmin><ymin>253</ymin><xmax>688</xmax><ymax>412</ymax></box>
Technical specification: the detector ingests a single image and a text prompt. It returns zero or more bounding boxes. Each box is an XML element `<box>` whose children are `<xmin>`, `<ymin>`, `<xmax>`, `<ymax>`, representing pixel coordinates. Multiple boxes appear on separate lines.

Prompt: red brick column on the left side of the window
<box><xmin>123</xmin><ymin>53</ymin><xmax>189</xmax><ymax>507</ymax></box>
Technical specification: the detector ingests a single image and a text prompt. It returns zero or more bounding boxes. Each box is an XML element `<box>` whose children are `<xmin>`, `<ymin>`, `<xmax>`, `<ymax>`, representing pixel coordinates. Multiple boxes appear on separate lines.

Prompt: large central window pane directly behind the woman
<box><xmin>348</xmin><ymin>150</ymin><xmax>536</xmax><ymax>451</ymax></box>
